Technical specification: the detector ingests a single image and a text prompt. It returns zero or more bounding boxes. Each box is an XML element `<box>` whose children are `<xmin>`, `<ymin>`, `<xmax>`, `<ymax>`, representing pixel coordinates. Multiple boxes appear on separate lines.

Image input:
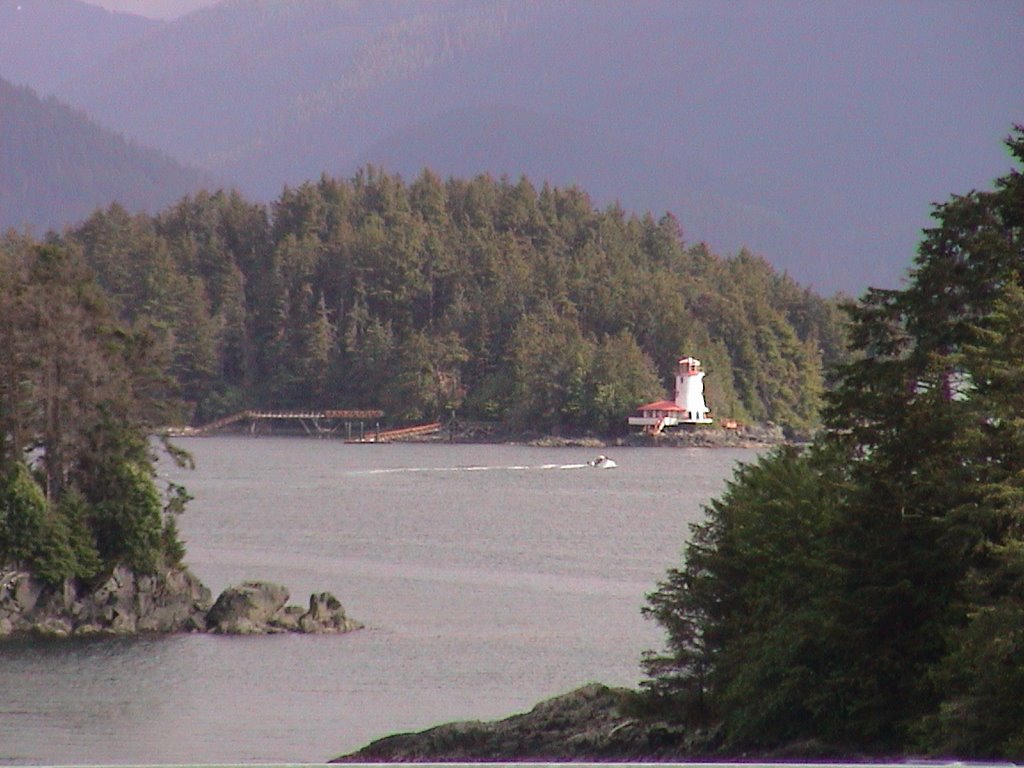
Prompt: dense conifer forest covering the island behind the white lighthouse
<box><xmin>46</xmin><ymin>168</ymin><xmax>844</xmax><ymax>432</ymax></box>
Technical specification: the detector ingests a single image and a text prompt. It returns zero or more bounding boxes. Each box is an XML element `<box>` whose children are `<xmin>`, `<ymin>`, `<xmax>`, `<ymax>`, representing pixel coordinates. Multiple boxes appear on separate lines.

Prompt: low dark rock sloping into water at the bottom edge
<box><xmin>331</xmin><ymin>683</ymin><xmax>692</xmax><ymax>763</ymax></box>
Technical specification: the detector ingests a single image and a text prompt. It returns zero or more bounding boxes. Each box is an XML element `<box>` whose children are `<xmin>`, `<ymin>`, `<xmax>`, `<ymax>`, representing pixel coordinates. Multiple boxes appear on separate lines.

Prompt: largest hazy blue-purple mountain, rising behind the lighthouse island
<box><xmin>12</xmin><ymin>0</ymin><xmax>1024</xmax><ymax>292</ymax></box>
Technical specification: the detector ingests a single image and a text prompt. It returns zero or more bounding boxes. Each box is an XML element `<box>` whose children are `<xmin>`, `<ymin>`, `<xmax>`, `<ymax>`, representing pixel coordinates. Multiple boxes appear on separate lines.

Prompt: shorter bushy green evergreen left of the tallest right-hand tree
<box><xmin>644</xmin><ymin>449</ymin><xmax>843</xmax><ymax>751</ymax></box>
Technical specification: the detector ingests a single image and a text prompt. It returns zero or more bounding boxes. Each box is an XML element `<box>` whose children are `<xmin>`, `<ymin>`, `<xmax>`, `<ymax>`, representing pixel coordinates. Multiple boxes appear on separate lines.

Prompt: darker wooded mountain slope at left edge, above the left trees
<box><xmin>0</xmin><ymin>79</ymin><xmax>210</xmax><ymax>234</ymax></box>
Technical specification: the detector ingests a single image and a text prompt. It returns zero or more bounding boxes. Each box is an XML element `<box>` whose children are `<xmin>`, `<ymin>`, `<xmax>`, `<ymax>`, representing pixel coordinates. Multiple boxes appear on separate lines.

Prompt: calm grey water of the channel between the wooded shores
<box><xmin>0</xmin><ymin>437</ymin><xmax>755</xmax><ymax>764</ymax></box>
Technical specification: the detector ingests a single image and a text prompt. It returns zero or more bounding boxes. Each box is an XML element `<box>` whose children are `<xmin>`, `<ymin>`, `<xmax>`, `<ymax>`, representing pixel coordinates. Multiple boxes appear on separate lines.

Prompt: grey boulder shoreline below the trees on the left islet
<box><xmin>0</xmin><ymin>567</ymin><xmax>362</xmax><ymax>638</ymax></box>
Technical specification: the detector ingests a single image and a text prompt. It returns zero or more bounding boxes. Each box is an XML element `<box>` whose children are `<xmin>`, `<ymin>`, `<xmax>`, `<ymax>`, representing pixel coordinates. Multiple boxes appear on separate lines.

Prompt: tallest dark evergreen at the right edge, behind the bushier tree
<box><xmin>828</xmin><ymin>126</ymin><xmax>1024</xmax><ymax>743</ymax></box>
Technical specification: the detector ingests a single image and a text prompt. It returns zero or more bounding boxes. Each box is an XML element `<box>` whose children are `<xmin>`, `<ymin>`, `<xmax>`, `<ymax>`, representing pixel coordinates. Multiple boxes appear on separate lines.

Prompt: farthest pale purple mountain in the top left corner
<box><xmin>0</xmin><ymin>0</ymin><xmax>160</xmax><ymax>93</ymax></box>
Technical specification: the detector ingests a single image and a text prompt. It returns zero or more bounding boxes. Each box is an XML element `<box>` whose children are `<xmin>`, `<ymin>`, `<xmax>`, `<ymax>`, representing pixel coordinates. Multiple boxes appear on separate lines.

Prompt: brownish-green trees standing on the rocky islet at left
<box><xmin>0</xmin><ymin>236</ymin><xmax>187</xmax><ymax>584</ymax></box>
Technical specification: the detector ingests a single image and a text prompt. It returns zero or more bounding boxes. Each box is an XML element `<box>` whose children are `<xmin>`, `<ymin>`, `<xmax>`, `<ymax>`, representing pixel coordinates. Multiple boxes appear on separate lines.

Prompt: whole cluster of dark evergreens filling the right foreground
<box><xmin>645</xmin><ymin>127</ymin><xmax>1024</xmax><ymax>760</ymax></box>
